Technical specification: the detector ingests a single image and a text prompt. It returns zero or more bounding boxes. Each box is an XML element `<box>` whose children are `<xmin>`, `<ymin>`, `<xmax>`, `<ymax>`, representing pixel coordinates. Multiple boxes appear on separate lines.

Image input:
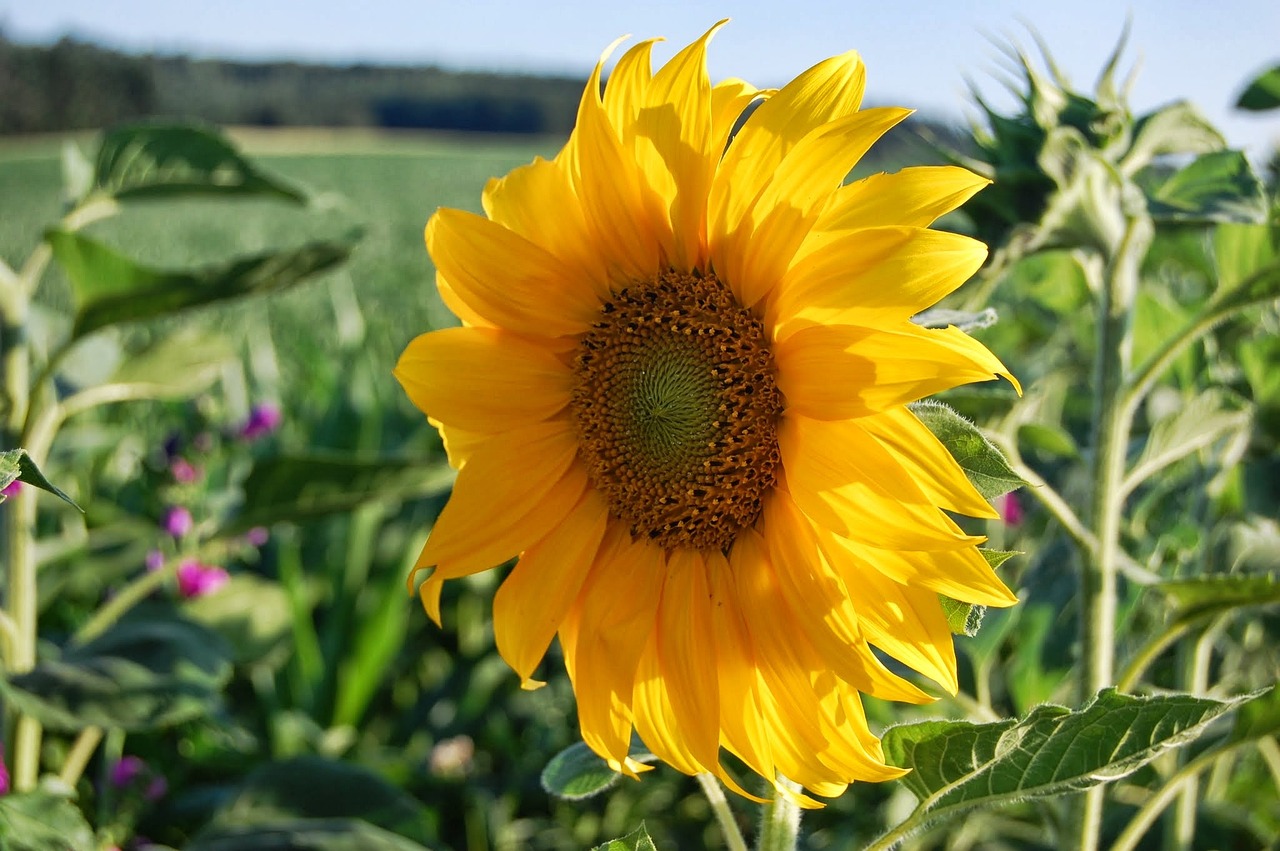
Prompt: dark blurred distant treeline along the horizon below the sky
<box><xmin>0</xmin><ymin>33</ymin><xmax>957</xmax><ymax>156</ymax></box>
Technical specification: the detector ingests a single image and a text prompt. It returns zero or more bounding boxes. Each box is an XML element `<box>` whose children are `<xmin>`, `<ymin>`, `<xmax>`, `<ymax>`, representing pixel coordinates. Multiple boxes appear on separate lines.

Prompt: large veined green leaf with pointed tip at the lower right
<box><xmin>883</xmin><ymin>688</ymin><xmax>1252</xmax><ymax>822</ymax></box>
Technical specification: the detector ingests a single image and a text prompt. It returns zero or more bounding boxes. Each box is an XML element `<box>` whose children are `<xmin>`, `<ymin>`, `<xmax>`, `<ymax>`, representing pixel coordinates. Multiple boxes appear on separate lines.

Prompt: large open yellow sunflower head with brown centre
<box><xmin>396</xmin><ymin>22</ymin><xmax>1015</xmax><ymax>806</ymax></box>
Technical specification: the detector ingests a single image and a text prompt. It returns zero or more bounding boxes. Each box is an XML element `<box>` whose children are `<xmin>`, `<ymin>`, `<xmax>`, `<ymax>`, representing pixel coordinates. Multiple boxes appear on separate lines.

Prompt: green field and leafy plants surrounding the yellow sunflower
<box><xmin>0</xmin><ymin>36</ymin><xmax>1280</xmax><ymax>850</ymax></box>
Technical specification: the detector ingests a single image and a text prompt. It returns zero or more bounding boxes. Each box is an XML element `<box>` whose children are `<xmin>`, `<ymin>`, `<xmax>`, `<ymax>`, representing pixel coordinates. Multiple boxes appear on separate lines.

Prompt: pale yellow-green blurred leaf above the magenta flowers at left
<box><xmin>109</xmin><ymin>328</ymin><xmax>236</xmax><ymax>399</ymax></box>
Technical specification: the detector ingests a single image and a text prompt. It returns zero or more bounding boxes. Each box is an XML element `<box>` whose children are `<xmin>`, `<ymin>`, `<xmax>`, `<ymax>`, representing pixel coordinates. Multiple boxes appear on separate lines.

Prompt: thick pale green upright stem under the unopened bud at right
<box><xmin>1076</xmin><ymin>211</ymin><xmax>1152</xmax><ymax>851</ymax></box>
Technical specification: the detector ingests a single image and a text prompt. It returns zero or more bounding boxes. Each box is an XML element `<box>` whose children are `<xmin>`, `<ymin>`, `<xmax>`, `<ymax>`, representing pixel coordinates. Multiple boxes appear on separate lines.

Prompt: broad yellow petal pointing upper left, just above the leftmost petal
<box><xmin>426</xmin><ymin>207</ymin><xmax>600</xmax><ymax>337</ymax></box>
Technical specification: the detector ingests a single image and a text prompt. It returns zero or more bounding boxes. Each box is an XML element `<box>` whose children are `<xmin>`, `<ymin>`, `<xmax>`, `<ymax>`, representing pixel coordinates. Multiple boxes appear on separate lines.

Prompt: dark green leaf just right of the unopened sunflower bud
<box><xmin>1148</xmin><ymin>151</ymin><xmax>1267</xmax><ymax>224</ymax></box>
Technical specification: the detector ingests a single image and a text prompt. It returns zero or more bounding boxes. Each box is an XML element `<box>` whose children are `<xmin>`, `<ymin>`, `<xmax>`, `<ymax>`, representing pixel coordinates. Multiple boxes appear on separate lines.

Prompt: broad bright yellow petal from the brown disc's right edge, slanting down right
<box><xmin>778</xmin><ymin>413</ymin><xmax>979</xmax><ymax>550</ymax></box>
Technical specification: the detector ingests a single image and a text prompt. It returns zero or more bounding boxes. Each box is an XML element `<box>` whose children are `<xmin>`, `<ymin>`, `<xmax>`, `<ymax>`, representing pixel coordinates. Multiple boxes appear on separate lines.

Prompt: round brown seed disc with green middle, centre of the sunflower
<box><xmin>572</xmin><ymin>273</ymin><xmax>782</xmax><ymax>552</ymax></box>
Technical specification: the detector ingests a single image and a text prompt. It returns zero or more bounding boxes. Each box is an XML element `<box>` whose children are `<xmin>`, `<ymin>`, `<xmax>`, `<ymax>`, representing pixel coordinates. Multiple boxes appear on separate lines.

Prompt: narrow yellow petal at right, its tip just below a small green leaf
<box><xmin>858</xmin><ymin>407</ymin><xmax>1000</xmax><ymax>520</ymax></box>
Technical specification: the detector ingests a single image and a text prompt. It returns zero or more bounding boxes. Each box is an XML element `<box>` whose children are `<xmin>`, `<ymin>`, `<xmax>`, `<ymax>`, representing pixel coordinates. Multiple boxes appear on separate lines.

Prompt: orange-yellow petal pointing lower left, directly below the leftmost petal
<box><xmin>415</xmin><ymin>421</ymin><xmax>586</xmax><ymax>578</ymax></box>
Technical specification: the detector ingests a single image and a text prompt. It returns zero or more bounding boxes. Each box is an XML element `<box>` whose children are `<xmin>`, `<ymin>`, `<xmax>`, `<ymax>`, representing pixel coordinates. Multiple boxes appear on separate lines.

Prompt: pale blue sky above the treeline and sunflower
<box><xmin>0</xmin><ymin>0</ymin><xmax>1280</xmax><ymax>157</ymax></box>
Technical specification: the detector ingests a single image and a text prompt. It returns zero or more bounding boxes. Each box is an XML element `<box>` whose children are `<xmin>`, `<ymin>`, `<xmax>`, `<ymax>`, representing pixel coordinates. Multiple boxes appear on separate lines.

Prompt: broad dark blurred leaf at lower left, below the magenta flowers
<box><xmin>3</xmin><ymin>612</ymin><xmax>230</xmax><ymax>732</ymax></box>
